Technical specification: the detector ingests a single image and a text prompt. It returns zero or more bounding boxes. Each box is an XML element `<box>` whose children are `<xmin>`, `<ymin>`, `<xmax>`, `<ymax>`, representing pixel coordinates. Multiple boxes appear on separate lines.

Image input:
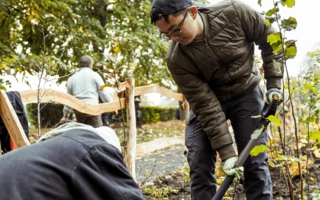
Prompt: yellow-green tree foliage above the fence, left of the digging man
<box><xmin>0</xmin><ymin>0</ymin><xmax>173</xmax><ymax>89</ymax></box>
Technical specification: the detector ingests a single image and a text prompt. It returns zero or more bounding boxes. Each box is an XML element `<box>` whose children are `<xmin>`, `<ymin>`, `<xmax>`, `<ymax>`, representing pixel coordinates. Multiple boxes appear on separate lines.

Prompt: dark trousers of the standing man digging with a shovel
<box><xmin>186</xmin><ymin>86</ymin><xmax>272</xmax><ymax>200</ymax></box>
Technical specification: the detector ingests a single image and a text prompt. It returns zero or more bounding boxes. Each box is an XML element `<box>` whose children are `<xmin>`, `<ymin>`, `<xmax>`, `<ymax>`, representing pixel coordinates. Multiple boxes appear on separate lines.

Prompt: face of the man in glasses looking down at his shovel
<box><xmin>155</xmin><ymin>9</ymin><xmax>196</xmax><ymax>45</ymax></box>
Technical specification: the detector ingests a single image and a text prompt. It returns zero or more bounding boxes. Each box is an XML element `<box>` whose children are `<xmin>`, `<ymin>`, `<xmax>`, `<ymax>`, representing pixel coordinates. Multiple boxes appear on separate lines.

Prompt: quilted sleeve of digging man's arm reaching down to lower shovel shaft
<box><xmin>168</xmin><ymin>43</ymin><xmax>235</xmax><ymax>161</ymax></box>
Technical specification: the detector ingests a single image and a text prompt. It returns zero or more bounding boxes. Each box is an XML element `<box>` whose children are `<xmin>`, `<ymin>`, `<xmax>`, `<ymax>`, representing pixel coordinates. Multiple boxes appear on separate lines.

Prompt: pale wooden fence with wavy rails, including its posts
<box><xmin>0</xmin><ymin>78</ymin><xmax>189</xmax><ymax>178</ymax></box>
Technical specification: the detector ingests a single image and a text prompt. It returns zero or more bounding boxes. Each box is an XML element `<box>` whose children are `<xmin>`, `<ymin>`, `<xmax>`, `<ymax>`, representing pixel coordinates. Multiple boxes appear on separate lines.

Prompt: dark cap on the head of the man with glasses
<box><xmin>150</xmin><ymin>0</ymin><xmax>193</xmax><ymax>24</ymax></box>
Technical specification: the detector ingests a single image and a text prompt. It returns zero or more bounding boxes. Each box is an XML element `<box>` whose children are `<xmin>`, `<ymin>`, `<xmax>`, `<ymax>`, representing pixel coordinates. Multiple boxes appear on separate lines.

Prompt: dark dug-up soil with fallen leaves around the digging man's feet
<box><xmin>144</xmin><ymin>159</ymin><xmax>320</xmax><ymax>200</ymax></box>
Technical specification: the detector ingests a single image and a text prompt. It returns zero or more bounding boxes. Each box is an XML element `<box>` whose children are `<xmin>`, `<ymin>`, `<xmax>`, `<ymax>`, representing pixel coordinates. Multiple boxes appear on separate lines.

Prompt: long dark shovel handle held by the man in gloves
<box><xmin>212</xmin><ymin>95</ymin><xmax>279</xmax><ymax>200</ymax></box>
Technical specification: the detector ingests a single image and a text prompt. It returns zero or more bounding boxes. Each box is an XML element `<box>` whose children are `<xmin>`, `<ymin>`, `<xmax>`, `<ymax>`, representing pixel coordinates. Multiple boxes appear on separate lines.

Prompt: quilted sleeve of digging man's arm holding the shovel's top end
<box><xmin>232</xmin><ymin>0</ymin><xmax>283</xmax><ymax>89</ymax></box>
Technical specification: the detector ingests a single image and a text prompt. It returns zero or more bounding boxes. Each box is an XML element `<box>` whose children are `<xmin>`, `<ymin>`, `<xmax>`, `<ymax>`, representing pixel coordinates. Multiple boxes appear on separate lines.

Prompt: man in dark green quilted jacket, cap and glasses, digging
<box><xmin>150</xmin><ymin>0</ymin><xmax>283</xmax><ymax>200</ymax></box>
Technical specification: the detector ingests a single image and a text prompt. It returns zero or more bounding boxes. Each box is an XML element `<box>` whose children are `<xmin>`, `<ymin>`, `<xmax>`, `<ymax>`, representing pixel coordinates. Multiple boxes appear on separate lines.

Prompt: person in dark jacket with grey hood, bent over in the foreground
<box><xmin>0</xmin><ymin>122</ymin><xmax>144</xmax><ymax>200</ymax></box>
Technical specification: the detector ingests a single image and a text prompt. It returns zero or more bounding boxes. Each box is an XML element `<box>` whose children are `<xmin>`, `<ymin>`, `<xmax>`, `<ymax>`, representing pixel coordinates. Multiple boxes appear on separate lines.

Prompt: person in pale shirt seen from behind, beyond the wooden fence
<box><xmin>60</xmin><ymin>55</ymin><xmax>112</xmax><ymax>127</ymax></box>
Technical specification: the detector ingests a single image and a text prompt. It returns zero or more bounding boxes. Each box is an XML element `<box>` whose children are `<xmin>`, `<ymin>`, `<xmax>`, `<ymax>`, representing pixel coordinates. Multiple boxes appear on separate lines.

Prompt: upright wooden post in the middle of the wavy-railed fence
<box><xmin>125</xmin><ymin>78</ymin><xmax>137</xmax><ymax>180</ymax></box>
